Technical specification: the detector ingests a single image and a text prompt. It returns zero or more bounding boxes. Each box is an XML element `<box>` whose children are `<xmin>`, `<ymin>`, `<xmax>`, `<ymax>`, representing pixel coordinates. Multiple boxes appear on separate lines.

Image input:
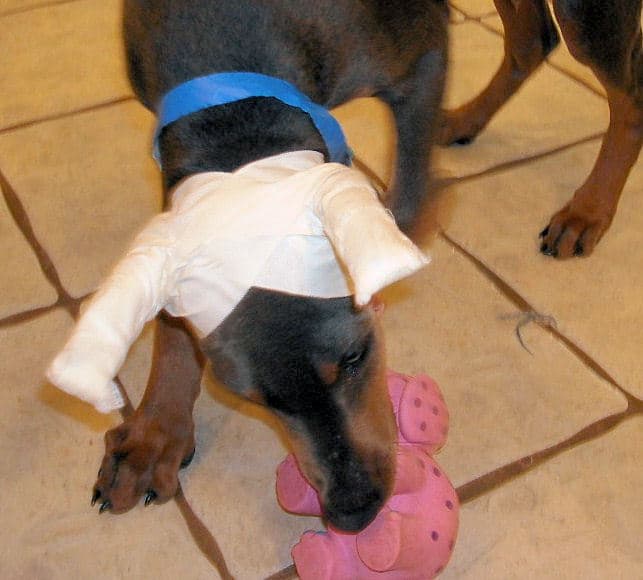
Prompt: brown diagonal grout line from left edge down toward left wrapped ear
<box><xmin>0</xmin><ymin>170</ymin><xmax>80</xmax><ymax>316</ymax></box>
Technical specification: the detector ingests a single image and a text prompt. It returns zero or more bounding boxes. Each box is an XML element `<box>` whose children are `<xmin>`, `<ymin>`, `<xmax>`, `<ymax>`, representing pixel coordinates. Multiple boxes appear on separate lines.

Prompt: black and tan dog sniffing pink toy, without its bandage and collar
<box><xmin>93</xmin><ymin>0</ymin><xmax>448</xmax><ymax>530</ymax></box>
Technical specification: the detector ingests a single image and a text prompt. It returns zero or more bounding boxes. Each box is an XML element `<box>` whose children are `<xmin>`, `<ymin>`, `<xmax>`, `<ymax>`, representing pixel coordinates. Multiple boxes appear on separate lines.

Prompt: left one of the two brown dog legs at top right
<box><xmin>439</xmin><ymin>0</ymin><xmax>560</xmax><ymax>145</ymax></box>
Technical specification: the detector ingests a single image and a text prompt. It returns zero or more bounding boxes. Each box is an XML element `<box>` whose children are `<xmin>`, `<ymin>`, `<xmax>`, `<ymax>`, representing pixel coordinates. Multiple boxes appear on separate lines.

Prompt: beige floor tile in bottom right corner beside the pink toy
<box><xmin>442</xmin><ymin>417</ymin><xmax>643</xmax><ymax>580</ymax></box>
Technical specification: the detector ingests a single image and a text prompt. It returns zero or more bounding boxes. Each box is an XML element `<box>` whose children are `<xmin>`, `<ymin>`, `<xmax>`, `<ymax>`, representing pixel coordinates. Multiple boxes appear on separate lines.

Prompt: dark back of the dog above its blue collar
<box><xmin>125</xmin><ymin>0</ymin><xmax>441</xmax><ymax>109</ymax></box>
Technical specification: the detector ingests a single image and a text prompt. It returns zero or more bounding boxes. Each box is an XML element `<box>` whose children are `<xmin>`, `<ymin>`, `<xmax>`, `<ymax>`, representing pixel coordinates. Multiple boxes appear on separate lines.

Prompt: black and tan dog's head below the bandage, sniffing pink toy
<box><xmin>202</xmin><ymin>288</ymin><xmax>396</xmax><ymax>531</ymax></box>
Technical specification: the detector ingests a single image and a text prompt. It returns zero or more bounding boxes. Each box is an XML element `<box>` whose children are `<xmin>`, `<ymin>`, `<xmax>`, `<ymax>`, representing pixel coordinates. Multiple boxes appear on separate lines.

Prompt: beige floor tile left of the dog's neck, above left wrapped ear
<box><xmin>0</xmin><ymin>102</ymin><xmax>161</xmax><ymax>296</ymax></box>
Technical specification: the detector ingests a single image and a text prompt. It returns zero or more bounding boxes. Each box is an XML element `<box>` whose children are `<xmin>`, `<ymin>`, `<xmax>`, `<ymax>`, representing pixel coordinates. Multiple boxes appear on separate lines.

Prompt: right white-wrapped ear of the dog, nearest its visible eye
<box><xmin>316</xmin><ymin>172</ymin><xmax>430</xmax><ymax>306</ymax></box>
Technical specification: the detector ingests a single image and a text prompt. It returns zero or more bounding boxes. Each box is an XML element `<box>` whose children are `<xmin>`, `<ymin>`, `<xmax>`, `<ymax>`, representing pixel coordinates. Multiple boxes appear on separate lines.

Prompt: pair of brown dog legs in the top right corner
<box><xmin>440</xmin><ymin>0</ymin><xmax>643</xmax><ymax>258</ymax></box>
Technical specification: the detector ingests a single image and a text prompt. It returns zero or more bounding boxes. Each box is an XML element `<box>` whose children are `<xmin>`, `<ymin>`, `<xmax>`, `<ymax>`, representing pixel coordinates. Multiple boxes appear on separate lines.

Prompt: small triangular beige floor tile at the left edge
<box><xmin>0</xmin><ymin>190</ymin><xmax>57</xmax><ymax>318</ymax></box>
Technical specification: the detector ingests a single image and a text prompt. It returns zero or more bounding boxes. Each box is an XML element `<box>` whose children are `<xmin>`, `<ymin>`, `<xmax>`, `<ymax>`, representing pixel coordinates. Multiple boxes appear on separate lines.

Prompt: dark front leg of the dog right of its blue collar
<box><xmin>378</xmin><ymin>49</ymin><xmax>446</xmax><ymax>235</ymax></box>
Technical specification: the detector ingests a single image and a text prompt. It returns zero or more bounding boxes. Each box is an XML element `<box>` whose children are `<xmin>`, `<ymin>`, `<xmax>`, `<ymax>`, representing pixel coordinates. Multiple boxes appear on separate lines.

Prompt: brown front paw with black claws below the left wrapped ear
<box><xmin>92</xmin><ymin>413</ymin><xmax>194</xmax><ymax>513</ymax></box>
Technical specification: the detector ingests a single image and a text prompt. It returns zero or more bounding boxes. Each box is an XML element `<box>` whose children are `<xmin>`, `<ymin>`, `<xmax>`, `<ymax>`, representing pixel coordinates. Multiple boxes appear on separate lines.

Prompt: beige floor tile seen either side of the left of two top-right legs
<box><xmin>437</xmin><ymin>23</ymin><xmax>609</xmax><ymax>175</ymax></box>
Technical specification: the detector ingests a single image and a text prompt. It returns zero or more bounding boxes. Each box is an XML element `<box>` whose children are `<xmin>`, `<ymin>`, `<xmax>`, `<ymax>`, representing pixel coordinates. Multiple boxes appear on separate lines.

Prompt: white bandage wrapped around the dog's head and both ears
<box><xmin>47</xmin><ymin>151</ymin><xmax>429</xmax><ymax>412</ymax></box>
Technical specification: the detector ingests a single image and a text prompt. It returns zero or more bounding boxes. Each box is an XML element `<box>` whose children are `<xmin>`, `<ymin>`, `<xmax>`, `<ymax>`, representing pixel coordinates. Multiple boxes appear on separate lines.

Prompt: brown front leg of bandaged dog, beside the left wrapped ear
<box><xmin>92</xmin><ymin>314</ymin><xmax>202</xmax><ymax>512</ymax></box>
